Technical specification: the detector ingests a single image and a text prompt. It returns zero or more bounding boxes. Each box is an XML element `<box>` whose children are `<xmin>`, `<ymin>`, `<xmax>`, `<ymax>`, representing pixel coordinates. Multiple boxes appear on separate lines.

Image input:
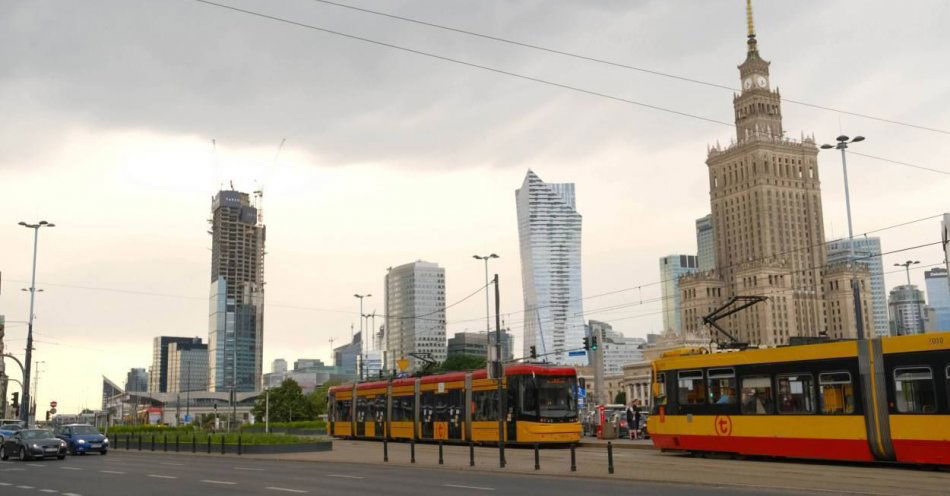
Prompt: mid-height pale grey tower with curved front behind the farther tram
<box><xmin>383</xmin><ymin>260</ymin><xmax>446</xmax><ymax>371</ymax></box>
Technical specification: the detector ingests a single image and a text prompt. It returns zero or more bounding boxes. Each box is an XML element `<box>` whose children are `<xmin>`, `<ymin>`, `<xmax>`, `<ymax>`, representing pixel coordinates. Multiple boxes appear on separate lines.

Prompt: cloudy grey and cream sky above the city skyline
<box><xmin>0</xmin><ymin>0</ymin><xmax>950</xmax><ymax>412</ymax></box>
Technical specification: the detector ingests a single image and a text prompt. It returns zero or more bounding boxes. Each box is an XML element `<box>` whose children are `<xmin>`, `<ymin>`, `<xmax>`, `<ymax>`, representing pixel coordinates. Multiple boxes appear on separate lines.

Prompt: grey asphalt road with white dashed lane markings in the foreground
<box><xmin>0</xmin><ymin>451</ymin><xmax>820</xmax><ymax>496</ymax></box>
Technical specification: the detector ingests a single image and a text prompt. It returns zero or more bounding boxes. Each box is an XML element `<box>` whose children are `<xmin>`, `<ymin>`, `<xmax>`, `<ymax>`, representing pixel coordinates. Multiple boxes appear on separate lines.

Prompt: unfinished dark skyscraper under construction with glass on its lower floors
<box><xmin>208</xmin><ymin>191</ymin><xmax>265</xmax><ymax>391</ymax></box>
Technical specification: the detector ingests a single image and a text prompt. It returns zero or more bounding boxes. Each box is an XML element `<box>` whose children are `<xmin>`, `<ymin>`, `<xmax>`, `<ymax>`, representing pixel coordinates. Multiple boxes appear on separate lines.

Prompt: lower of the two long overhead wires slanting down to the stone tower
<box><xmin>192</xmin><ymin>0</ymin><xmax>950</xmax><ymax>174</ymax></box>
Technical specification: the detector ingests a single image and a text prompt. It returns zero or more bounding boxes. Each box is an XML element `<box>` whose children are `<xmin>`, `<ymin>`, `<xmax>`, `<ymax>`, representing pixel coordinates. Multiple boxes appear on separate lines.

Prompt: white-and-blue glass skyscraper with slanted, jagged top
<box><xmin>515</xmin><ymin>170</ymin><xmax>587</xmax><ymax>365</ymax></box>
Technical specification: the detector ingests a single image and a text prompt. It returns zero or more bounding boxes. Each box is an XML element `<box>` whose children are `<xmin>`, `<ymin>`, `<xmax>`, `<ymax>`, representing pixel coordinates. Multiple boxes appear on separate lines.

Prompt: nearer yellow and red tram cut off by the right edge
<box><xmin>648</xmin><ymin>333</ymin><xmax>950</xmax><ymax>465</ymax></box>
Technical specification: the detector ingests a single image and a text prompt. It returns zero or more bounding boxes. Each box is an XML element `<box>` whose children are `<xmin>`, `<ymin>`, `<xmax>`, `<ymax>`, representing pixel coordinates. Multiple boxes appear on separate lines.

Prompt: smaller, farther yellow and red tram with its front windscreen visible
<box><xmin>328</xmin><ymin>365</ymin><xmax>581</xmax><ymax>444</ymax></box>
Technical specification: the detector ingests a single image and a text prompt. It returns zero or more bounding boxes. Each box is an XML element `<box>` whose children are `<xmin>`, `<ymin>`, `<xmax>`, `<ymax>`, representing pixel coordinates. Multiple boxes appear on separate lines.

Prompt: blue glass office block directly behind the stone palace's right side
<box><xmin>825</xmin><ymin>236</ymin><xmax>891</xmax><ymax>337</ymax></box>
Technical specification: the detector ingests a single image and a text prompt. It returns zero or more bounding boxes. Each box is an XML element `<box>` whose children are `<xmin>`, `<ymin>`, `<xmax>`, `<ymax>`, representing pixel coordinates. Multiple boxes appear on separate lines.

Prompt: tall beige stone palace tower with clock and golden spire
<box><xmin>679</xmin><ymin>1</ymin><xmax>873</xmax><ymax>346</ymax></box>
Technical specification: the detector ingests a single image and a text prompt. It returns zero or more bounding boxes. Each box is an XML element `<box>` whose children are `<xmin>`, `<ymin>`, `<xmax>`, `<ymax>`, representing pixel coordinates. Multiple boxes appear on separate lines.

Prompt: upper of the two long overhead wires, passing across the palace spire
<box><xmin>312</xmin><ymin>0</ymin><xmax>950</xmax><ymax>137</ymax></box>
